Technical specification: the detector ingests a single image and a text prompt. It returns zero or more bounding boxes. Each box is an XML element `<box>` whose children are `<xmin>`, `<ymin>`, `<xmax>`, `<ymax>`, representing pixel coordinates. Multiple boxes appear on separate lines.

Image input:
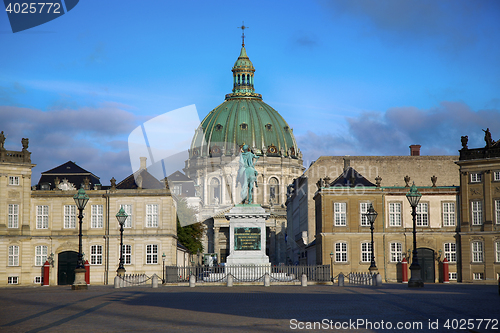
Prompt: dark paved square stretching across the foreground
<box><xmin>0</xmin><ymin>284</ymin><xmax>500</xmax><ymax>333</ymax></box>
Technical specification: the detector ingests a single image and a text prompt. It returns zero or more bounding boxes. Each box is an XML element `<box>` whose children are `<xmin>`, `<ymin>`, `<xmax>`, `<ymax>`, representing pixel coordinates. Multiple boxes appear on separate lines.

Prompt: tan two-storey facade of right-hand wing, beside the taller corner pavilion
<box><xmin>315</xmin><ymin>187</ymin><xmax>459</xmax><ymax>282</ymax></box>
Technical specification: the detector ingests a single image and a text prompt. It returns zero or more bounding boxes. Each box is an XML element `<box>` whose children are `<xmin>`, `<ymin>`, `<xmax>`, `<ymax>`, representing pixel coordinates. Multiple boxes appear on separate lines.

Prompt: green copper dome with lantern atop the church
<box><xmin>189</xmin><ymin>46</ymin><xmax>298</xmax><ymax>158</ymax></box>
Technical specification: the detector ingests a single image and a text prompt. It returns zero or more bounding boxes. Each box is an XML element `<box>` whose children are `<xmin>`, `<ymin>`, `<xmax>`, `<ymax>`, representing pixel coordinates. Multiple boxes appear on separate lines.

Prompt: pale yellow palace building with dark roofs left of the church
<box><xmin>0</xmin><ymin>139</ymin><xmax>180</xmax><ymax>285</ymax></box>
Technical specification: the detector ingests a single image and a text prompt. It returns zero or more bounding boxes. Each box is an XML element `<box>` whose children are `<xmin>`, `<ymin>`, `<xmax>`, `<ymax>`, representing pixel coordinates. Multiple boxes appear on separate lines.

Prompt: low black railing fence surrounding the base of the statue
<box><xmin>165</xmin><ymin>265</ymin><xmax>331</xmax><ymax>283</ymax></box>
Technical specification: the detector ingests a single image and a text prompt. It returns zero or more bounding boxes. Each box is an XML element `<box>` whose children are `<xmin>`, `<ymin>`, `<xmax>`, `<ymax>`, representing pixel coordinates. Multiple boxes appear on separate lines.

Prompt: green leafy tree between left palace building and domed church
<box><xmin>177</xmin><ymin>198</ymin><xmax>204</xmax><ymax>254</ymax></box>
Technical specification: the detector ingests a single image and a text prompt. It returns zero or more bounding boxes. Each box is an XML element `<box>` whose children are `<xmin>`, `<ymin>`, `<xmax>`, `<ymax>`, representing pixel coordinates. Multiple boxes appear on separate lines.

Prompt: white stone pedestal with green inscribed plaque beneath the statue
<box><xmin>226</xmin><ymin>205</ymin><xmax>270</xmax><ymax>266</ymax></box>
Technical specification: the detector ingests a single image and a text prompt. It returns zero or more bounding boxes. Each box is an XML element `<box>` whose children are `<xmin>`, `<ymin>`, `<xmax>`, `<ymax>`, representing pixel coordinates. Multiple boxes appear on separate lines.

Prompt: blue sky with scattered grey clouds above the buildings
<box><xmin>0</xmin><ymin>0</ymin><xmax>500</xmax><ymax>184</ymax></box>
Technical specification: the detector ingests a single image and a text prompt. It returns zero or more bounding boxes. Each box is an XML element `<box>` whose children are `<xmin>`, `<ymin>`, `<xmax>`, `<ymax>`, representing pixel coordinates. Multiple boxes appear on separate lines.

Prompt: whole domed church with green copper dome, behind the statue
<box><xmin>184</xmin><ymin>44</ymin><xmax>304</xmax><ymax>264</ymax></box>
